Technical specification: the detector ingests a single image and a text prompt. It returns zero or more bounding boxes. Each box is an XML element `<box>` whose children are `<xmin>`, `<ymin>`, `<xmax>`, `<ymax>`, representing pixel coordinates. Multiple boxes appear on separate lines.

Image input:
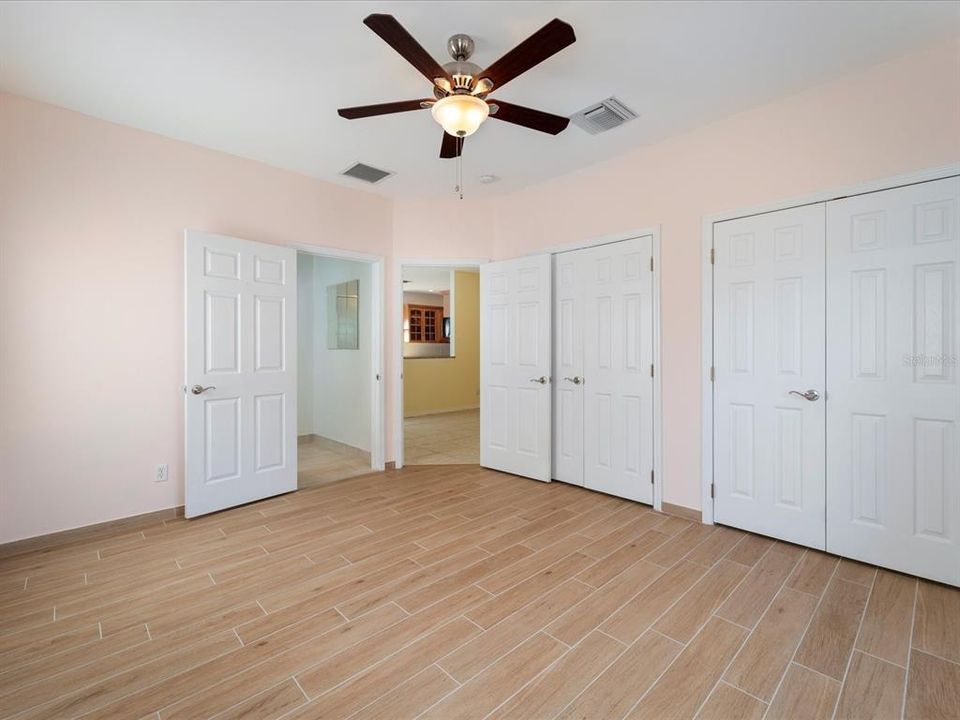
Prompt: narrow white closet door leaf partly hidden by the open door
<box><xmin>553</xmin><ymin>251</ymin><xmax>585</xmax><ymax>485</ymax></box>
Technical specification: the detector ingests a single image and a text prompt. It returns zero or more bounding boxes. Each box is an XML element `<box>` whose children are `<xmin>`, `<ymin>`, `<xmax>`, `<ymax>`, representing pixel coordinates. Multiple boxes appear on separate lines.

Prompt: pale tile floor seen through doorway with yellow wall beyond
<box><xmin>403</xmin><ymin>410</ymin><xmax>480</xmax><ymax>465</ymax></box>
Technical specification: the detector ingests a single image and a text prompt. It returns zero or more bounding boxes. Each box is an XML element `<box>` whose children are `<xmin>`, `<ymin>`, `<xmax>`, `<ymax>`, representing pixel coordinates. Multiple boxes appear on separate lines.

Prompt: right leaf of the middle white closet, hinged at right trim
<box><xmin>571</xmin><ymin>236</ymin><xmax>653</xmax><ymax>503</ymax></box>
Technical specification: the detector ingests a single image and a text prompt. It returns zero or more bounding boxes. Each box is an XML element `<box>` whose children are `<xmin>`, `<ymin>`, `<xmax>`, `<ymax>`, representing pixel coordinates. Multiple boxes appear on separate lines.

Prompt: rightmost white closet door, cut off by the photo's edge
<box><xmin>827</xmin><ymin>178</ymin><xmax>960</xmax><ymax>585</ymax></box>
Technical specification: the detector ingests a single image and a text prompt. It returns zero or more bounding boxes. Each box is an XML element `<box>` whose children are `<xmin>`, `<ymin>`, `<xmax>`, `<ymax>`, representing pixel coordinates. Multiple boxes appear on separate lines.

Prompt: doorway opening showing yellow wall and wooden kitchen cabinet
<box><xmin>397</xmin><ymin>261</ymin><xmax>480</xmax><ymax>467</ymax></box>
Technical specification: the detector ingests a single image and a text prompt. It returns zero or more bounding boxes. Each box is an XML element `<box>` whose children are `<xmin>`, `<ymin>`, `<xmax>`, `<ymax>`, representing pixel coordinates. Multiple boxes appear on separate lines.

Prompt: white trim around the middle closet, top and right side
<box><xmin>526</xmin><ymin>225</ymin><xmax>665</xmax><ymax>512</ymax></box>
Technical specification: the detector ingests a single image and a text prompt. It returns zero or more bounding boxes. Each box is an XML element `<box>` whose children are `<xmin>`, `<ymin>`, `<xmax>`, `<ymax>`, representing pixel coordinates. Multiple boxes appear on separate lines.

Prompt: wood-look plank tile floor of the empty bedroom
<box><xmin>0</xmin><ymin>466</ymin><xmax>960</xmax><ymax>720</ymax></box>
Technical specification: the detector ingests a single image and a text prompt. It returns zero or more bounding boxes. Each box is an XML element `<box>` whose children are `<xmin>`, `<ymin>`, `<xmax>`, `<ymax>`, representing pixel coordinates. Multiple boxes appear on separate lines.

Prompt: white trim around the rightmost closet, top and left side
<box><xmin>700</xmin><ymin>163</ymin><xmax>960</xmax><ymax>525</ymax></box>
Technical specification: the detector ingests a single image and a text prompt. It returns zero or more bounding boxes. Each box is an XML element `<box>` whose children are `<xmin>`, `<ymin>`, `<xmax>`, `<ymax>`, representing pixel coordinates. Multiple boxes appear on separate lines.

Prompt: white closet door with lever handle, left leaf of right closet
<box><xmin>712</xmin><ymin>204</ymin><xmax>826</xmax><ymax>549</ymax></box>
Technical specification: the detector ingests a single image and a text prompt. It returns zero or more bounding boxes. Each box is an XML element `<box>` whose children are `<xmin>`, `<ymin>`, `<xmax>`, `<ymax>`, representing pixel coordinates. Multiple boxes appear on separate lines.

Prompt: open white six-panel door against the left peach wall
<box><xmin>184</xmin><ymin>230</ymin><xmax>297</xmax><ymax>517</ymax></box>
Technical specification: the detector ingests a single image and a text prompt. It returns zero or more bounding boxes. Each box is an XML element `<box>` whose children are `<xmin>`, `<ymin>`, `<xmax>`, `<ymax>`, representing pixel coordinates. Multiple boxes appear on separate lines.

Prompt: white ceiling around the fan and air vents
<box><xmin>0</xmin><ymin>0</ymin><xmax>960</xmax><ymax>197</ymax></box>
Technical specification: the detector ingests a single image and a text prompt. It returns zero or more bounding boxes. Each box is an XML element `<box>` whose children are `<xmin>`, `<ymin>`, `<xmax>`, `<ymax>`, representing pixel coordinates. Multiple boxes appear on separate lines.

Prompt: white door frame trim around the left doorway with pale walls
<box><xmin>298</xmin><ymin>243</ymin><xmax>387</xmax><ymax>471</ymax></box>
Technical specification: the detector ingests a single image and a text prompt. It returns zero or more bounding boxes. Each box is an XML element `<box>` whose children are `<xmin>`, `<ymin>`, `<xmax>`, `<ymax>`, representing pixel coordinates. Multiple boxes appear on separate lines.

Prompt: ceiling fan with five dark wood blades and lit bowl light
<box><xmin>337</xmin><ymin>14</ymin><xmax>577</xmax><ymax>158</ymax></box>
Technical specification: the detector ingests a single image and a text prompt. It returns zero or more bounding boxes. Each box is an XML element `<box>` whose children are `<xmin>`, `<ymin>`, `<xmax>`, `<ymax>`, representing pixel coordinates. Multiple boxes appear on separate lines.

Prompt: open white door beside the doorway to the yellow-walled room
<box><xmin>480</xmin><ymin>255</ymin><xmax>552</xmax><ymax>482</ymax></box>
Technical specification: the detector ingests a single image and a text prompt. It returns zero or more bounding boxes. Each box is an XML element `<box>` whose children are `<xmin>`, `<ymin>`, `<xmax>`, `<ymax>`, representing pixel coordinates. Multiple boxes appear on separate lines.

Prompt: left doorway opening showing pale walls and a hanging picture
<box><xmin>297</xmin><ymin>252</ymin><xmax>379</xmax><ymax>489</ymax></box>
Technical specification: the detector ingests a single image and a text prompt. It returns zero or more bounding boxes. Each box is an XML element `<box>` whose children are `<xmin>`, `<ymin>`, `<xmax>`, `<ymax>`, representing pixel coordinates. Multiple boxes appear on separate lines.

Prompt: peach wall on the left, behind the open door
<box><xmin>0</xmin><ymin>95</ymin><xmax>392</xmax><ymax>542</ymax></box>
